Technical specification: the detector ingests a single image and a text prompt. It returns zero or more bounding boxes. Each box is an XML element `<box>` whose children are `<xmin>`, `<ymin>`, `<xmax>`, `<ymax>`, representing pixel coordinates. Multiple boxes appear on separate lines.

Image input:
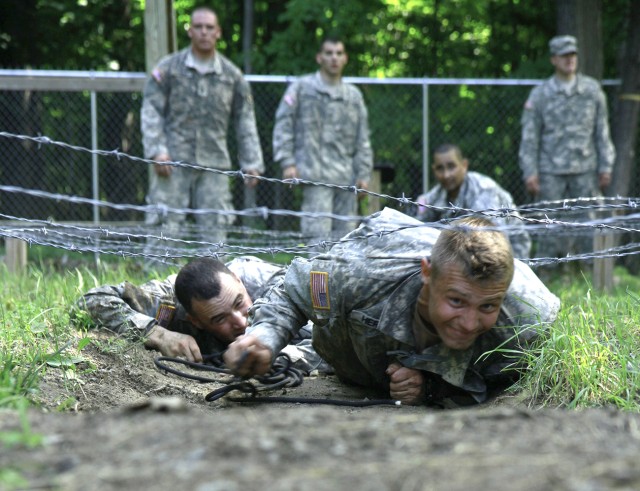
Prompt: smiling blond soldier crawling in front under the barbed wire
<box><xmin>225</xmin><ymin>209</ymin><xmax>559</xmax><ymax>410</ymax></box>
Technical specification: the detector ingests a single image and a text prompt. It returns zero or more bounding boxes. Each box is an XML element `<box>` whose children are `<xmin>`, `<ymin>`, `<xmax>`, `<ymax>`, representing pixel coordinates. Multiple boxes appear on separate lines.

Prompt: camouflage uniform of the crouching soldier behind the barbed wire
<box><xmin>416</xmin><ymin>172</ymin><xmax>531</xmax><ymax>259</ymax></box>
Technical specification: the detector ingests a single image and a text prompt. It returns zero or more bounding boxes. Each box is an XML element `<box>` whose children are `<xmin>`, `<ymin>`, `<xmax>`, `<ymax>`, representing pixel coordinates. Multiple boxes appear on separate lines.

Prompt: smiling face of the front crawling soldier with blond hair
<box><xmin>421</xmin><ymin>259</ymin><xmax>508</xmax><ymax>350</ymax></box>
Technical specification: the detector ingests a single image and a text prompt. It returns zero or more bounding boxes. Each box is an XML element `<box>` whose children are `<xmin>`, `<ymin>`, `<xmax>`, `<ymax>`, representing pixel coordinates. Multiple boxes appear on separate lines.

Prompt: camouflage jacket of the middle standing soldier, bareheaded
<box><xmin>273</xmin><ymin>72</ymin><xmax>373</xmax><ymax>185</ymax></box>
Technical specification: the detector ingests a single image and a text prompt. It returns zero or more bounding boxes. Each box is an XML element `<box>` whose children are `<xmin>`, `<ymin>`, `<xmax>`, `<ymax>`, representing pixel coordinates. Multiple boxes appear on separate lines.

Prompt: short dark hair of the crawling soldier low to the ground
<box><xmin>175</xmin><ymin>257</ymin><xmax>232</xmax><ymax>313</ymax></box>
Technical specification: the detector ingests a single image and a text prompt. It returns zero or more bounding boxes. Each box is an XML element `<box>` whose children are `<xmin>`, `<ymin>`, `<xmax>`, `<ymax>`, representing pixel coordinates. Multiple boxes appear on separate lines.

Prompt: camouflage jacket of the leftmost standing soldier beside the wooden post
<box><xmin>141</xmin><ymin>48</ymin><xmax>264</xmax><ymax>173</ymax></box>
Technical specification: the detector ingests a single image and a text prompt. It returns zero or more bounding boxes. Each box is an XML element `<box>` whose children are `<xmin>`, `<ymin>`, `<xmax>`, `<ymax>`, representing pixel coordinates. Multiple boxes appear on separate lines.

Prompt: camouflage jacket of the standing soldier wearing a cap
<box><xmin>519</xmin><ymin>74</ymin><xmax>615</xmax><ymax>179</ymax></box>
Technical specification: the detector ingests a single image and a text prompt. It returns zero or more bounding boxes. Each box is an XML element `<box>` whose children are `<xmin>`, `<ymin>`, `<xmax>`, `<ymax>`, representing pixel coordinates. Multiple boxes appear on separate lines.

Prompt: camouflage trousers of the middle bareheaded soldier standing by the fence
<box><xmin>300</xmin><ymin>186</ymin><xmax>357</xmax><ymax>246</ymax></box>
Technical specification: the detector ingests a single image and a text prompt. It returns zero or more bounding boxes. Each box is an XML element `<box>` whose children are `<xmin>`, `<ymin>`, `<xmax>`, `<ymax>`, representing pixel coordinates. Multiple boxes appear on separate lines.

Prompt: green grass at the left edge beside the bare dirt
<box><xmin>0</xmin><ymin>262</ymin><xmax>154</xmax><ymax>408</ymax></box>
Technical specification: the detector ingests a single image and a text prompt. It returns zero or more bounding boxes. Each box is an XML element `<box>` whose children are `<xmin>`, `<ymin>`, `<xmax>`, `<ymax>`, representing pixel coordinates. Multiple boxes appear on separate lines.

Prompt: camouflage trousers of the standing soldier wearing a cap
<box><xmin>536</xmin><ymin>172</ymin><xmax>601</xmax><ymax>264</ymax></box>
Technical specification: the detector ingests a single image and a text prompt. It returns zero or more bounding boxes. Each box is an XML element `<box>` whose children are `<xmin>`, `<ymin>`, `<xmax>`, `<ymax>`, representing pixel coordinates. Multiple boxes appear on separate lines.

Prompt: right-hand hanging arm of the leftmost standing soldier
<box><xmin>232</xmin><ymin>78</ymin><xmax>264</xmax><ymax>176</ymax></box>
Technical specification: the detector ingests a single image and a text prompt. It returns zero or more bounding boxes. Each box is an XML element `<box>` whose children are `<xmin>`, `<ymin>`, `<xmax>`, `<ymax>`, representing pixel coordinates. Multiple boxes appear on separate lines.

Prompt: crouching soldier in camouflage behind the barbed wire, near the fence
<box><xmin>416</xmin><ymin>144</ymin><xmax>531</xmax><ymax>259</ymax></box>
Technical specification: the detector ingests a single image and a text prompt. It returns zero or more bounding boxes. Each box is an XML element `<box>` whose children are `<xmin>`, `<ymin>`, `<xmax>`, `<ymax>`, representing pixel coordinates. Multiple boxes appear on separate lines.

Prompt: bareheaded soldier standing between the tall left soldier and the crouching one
<box><xmin>273</xmin><ymin>38</ymin><xmax>373</xmax><ymax>245</ymax></box>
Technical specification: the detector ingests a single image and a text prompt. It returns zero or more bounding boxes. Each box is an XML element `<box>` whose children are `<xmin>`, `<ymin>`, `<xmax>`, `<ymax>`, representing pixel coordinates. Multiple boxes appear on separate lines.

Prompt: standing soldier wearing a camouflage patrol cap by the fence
<box><xmin>519</xmin><ymin>36</ymin><xmax>615</xmax><ymax>264</ymax></box>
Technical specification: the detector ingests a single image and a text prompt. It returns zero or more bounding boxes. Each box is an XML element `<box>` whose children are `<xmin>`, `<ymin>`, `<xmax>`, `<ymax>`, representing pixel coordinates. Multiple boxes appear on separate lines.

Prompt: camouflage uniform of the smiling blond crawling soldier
<box><xmin>247</xmin><ymin>209</ymin><xmax>559</xmax><ymax>402</ymax></box>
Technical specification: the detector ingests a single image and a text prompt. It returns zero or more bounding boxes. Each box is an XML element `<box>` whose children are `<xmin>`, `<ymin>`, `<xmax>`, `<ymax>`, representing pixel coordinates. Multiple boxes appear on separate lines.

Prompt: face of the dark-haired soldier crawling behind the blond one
<box><xmin>189</xmin><ymin>273</ymin><xmax>253</xmax><ymax>344</ymax></box>
